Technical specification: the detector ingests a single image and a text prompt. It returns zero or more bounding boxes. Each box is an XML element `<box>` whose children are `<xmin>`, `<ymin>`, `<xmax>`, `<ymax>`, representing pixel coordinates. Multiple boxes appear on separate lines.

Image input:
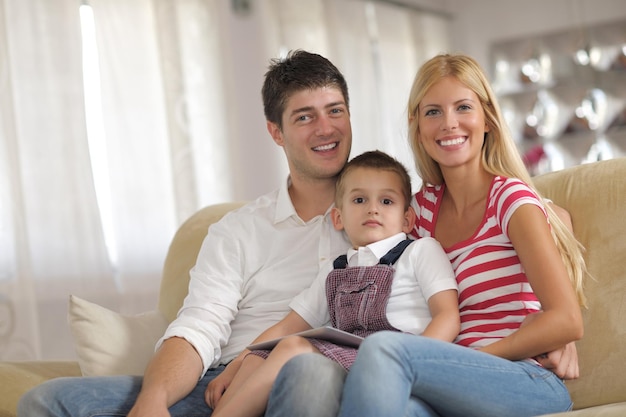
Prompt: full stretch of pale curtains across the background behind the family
<box><xmin>0</xmin><ymin>0</ymin><xmax>448</xmax><ymax>360</ymax></box>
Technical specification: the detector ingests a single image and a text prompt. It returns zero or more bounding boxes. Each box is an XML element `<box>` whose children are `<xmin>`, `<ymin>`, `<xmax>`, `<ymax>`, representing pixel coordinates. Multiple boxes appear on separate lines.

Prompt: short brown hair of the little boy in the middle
<box><xmin>335</xmin><ymin>150</ymin><xmax>412</xmax><ymax>210</ymax></box>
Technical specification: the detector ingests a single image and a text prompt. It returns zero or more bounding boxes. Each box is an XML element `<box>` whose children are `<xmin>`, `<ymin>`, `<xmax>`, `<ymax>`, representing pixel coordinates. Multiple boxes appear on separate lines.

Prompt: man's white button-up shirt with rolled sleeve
<box><xmin>156</xmin><ymin>177</ymin><xmax>350</xmax><ymax>375</ymax></box>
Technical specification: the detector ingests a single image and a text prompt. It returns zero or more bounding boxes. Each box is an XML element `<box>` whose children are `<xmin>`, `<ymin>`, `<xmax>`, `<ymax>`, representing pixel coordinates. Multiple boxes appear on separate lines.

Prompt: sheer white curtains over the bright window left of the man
<box><xmin>0</xmin><ymin>0</ymin><xmax>233</xmax><ymax>359</ymax></box>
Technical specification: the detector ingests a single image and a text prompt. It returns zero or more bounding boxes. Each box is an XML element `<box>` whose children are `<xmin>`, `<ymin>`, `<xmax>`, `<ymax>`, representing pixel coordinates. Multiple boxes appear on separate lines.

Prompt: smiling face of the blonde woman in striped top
<box><xmin>417</xmin><ymin>77</ymin><xmax>489</xmax><ymax>169</ymax></box>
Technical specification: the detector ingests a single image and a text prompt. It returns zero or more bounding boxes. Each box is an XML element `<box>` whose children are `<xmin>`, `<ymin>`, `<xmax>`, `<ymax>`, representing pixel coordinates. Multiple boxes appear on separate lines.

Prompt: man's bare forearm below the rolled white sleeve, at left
<box><xmin>128</xmin><ymin>337</ymin><xmax>202</xmax><ymax>417</ymax></box>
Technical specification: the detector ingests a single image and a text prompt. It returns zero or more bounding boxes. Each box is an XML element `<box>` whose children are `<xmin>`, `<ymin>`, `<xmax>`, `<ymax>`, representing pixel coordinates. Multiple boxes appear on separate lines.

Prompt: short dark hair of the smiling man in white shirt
<box><xmin>261</xmin><ymin>49</ymin><xmax>349</xmax><ymax>130</ymax></box>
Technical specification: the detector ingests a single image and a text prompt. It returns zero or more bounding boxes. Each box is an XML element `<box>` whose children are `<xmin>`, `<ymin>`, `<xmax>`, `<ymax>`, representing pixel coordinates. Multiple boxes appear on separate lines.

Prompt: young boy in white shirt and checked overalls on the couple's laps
<box><xmin>213</xmin><ymin>151</ymin><xmax>460</xmax><ymax>417</ymax></box>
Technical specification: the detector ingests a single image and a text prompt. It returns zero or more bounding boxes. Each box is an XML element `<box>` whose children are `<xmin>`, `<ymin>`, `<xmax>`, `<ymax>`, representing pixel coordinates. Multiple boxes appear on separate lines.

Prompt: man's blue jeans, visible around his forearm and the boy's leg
<box><xmin>17</xmin><ymin>354</ymin><xmax>346</xmax><ymax>417</ymax></box>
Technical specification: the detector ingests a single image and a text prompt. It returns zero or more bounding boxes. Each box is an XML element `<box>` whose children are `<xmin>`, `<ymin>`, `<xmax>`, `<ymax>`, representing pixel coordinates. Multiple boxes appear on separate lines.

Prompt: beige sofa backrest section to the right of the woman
<box><xmin>533</xmin><ymin>158</ymin><xmax>626</xmax><ymax>409</ymax></box>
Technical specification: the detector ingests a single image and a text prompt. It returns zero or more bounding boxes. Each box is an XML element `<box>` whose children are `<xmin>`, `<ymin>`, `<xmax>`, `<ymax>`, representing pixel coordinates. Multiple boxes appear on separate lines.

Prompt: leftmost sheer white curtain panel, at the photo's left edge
<box><xmin>0</xmin><ymin>0</ymin><xmax>112</xmax><ymax>358</ymax></box>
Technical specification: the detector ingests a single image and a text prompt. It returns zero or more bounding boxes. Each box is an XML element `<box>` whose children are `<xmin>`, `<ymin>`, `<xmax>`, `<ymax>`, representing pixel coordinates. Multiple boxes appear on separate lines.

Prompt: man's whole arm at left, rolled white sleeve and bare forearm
<box><xmin>129</xmin><ymin>210</ymin><xmax>249</xmax><ymax>417</ymax></box>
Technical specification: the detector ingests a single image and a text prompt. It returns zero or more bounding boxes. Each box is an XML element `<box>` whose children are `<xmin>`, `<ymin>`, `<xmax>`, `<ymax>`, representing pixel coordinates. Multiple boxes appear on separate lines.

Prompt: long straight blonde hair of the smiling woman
<box><xmin>408</xmin><ymin>54</ymin><xmax>587</xmax><ymax>306</ymax></box>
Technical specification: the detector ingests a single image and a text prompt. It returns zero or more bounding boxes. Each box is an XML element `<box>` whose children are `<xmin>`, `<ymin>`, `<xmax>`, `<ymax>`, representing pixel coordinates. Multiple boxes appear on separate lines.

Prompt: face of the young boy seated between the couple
<box><xmin>332</xmin><ymin>168</ymin><xmax>415</xmax><ymax>248</ymax></box>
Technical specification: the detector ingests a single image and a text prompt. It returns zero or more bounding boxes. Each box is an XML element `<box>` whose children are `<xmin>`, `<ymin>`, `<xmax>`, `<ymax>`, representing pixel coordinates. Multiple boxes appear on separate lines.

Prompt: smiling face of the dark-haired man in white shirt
<box><xmin>268</xmin><ymin>87</ymin><xmax>352</xmax><ymax>181</ymax></box>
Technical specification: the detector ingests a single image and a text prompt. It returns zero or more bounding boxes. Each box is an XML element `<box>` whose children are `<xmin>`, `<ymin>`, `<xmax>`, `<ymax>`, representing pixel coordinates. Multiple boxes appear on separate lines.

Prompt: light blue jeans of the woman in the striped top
<box><xmin>339</xmin><ymin>332</ymin><xmax>572</xmax><ymax>417</ymax></box>
